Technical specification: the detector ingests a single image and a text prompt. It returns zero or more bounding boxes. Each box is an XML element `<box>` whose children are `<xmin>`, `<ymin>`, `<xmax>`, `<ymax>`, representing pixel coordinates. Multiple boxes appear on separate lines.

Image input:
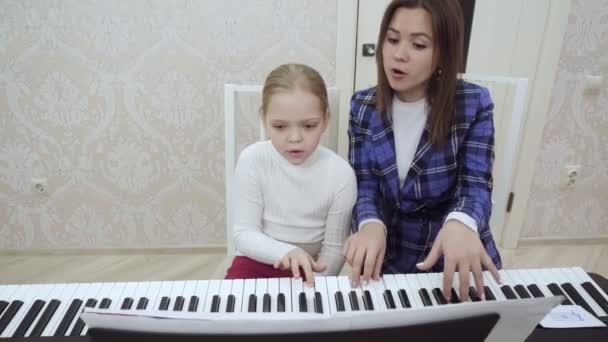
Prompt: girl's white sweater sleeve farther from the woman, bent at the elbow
<box><xmin>233</xmin><ymin>149</ymin><xmax>296</xmax><ymax>264</ymax></box>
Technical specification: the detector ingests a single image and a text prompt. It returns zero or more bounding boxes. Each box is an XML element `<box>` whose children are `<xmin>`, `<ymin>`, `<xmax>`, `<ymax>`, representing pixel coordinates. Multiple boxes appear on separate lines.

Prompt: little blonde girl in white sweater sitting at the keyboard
<box><xmin>226</xmin><ymin>64</ymin><xmax>357</xmax><ymax>285</ymax></box>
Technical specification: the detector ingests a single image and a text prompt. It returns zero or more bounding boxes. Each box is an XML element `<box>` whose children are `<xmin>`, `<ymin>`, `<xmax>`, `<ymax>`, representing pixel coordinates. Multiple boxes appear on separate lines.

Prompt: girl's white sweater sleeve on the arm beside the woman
<box><xmin>317</xmin><ymin>162</ymin><xmax>357</xmax><ymax>276</ymax></box>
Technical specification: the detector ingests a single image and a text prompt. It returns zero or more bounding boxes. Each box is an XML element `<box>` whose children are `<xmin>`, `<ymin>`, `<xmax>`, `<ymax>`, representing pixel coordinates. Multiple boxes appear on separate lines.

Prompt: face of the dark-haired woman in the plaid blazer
<box><xmin>382</xmin><ymin>8</ymin><xmax>435</xmax><ymax>102</ymax></box>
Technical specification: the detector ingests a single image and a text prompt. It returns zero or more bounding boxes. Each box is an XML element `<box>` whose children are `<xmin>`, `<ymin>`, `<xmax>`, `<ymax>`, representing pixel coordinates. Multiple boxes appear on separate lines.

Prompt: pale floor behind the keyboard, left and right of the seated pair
<box><xmin>0</xmin><ymin>244</ymin><xmax>608</xmax><ymax>284</ymax></box>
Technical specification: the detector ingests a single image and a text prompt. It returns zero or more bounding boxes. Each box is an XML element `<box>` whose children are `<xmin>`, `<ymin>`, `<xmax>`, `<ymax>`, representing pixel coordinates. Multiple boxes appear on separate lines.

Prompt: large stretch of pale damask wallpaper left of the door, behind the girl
<box><xmin>0</xmin><ymin>0</ymin><xmax>337</xmax><ymax>249</ymax></box>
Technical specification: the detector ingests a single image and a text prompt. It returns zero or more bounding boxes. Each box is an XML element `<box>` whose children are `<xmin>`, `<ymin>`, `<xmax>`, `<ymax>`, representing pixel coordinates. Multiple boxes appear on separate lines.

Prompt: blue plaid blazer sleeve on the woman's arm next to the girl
<box><xmin>348</xmin><ymin>96</ymin><xmax>381</xmax><ymax>232</ymax></box>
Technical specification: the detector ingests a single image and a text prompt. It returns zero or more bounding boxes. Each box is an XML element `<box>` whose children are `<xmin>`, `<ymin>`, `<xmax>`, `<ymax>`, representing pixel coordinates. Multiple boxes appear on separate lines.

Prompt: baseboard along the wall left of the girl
<box><xmin>0</xmin><ymin>245</ymin><xmax>226</xmax><ymax>256</ymax></box>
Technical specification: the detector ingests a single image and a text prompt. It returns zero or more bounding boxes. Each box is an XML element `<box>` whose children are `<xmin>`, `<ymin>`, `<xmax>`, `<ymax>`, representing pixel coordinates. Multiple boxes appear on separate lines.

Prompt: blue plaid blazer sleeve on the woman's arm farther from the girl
<box><xmin>448</xmin><ymin>88</ymin><xmax>494</xmax><ymax>233</ymax></box>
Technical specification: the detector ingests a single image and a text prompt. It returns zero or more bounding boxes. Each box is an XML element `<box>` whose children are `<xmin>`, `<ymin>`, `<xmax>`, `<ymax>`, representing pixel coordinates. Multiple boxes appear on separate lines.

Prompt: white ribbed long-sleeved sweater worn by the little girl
<box><xmin>234</xmin><ymin>141</ymin><xmax>357</xmax><ymax>275</ymax></box>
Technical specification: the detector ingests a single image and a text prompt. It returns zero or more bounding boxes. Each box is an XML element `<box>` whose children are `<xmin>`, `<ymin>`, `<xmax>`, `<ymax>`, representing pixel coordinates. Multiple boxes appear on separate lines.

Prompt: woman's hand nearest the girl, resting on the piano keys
<box><xmin>343</xmin><ymin>222</ymin><xmax>386</xmax><ymax>286</ymax></box>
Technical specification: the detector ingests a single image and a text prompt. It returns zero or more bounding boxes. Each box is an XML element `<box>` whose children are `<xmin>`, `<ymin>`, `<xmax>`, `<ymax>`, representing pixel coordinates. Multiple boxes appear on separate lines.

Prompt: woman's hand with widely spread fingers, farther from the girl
<box><xmin>416</xmin><ymin>220</ymin><xmax>501</xmax><ymax>302</ymax></box>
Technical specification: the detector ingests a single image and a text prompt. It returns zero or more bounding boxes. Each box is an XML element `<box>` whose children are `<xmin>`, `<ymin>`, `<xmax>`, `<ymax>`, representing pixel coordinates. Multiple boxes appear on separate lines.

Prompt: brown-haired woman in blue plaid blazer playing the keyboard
<box><xmin>344</xmin><ymin>0</ymin><xmax>501</xmax><ymax>300</ymax></box>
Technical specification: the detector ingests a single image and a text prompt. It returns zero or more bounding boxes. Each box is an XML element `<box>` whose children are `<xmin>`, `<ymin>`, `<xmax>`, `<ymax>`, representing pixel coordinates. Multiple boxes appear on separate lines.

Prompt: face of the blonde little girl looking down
<box><xmin>264</xmin><ymin>89</ymin><xmax>327</xmax><ymax>165</ymax></box>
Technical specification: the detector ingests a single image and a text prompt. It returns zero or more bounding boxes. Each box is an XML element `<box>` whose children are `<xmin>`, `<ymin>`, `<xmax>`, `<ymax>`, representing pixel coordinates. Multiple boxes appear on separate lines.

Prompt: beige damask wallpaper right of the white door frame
<box><xmin>522</xmin><ymin>0</ymin><xmax>608</xmax><ymax>237</ymax></box>
